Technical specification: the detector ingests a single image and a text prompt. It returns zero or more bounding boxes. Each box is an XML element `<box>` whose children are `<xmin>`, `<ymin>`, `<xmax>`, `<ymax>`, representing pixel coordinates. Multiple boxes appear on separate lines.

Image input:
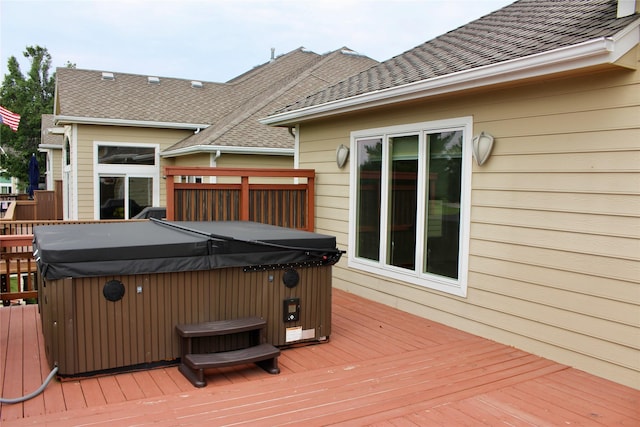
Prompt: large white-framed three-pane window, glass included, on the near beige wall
<box><xmin>349</xmin><ymin>118</ymin><xmax>472</xmax><ymax>296</ymax></box>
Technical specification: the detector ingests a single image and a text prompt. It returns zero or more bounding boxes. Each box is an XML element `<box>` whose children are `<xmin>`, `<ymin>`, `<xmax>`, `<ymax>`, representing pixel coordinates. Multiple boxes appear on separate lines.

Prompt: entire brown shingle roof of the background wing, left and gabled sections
<box><xmin>56</xmin><ymin>48</ymin><xmax>378</xmax><ymax>150</ymax></box>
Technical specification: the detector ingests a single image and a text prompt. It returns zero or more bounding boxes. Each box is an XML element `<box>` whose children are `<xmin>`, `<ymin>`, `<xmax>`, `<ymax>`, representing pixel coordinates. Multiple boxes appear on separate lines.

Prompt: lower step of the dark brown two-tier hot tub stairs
<box><xmin>178</xmin><ymin>344</ymin><xmax>280</xmax><ymax>387</ymax></box>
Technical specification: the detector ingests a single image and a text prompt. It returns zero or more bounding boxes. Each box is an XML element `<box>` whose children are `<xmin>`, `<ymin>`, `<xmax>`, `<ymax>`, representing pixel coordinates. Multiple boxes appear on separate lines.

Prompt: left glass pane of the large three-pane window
<box><xmin>356</xmin><ymin>138</ymin><xmax>382</xmax><ymax>261</ymax></box>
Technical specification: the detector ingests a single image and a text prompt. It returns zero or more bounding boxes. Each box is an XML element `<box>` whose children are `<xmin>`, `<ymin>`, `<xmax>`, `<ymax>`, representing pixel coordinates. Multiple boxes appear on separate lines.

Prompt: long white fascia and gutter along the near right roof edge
<box><xmin>260</xmin><ymin>23</ymin><xmax>640</xmax><ymax>126</ymax></box>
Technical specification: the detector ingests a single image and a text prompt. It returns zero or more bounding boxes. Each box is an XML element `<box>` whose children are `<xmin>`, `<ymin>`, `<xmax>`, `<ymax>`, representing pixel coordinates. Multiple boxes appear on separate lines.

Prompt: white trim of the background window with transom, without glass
<box><xmin>93</xmin><ymin>141</ymin><xmax>160</xmax><ymax>219</ymax></box>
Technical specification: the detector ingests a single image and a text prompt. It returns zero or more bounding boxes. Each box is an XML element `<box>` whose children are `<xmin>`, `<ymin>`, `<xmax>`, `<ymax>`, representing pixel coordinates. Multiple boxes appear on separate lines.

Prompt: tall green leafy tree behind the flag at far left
<box><xmin>0</xmin><ymin>46</ymin><xmax>55</xmax><ymax>189</ymax></box>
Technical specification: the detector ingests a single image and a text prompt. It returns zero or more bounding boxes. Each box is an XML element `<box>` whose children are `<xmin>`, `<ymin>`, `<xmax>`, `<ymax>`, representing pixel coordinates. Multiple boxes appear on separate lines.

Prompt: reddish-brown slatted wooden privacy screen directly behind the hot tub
<box><xmin>165</xmin><ymin>166</ymin><xmax>315</xmax><ymax>231</ymax></box>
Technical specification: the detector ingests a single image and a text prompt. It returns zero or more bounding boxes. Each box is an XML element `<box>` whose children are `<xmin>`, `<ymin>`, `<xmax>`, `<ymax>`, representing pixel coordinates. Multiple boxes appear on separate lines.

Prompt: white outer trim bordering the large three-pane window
<box><xmin>347</xmin><ymin>116</ymin><xmax>473</xmax><ymax>297</ymax></box>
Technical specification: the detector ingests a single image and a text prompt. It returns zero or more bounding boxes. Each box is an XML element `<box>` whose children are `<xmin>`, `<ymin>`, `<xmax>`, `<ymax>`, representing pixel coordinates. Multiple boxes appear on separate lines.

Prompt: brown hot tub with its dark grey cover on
<box><xmin>33</xmin><ymin>220</ymin><xmax>341</xmax><ymax>376</ymax></box>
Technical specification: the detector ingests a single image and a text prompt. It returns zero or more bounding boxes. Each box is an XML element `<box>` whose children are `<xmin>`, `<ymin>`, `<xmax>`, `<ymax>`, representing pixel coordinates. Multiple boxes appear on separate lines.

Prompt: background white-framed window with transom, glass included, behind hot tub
<box><xmin>95</xmin><ymin>143</ymin><xmax>160</xmax><ymax>219</ymax></box>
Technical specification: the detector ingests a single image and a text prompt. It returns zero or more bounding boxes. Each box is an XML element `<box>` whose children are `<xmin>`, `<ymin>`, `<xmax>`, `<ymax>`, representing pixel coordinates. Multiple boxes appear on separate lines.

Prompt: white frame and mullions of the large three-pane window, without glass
<box><xmin>347</xmin><ymin>116</ymin><xmax>473</xmax><ymax>297</ymax></box>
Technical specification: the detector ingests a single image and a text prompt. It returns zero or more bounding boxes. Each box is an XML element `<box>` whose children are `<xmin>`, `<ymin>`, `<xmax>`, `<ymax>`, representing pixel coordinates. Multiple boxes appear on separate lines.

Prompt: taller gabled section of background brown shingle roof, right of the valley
<box><xmin>166</xmin><ymin>48</ymin><xmax>377</xmax><ymax>151</ymax></box>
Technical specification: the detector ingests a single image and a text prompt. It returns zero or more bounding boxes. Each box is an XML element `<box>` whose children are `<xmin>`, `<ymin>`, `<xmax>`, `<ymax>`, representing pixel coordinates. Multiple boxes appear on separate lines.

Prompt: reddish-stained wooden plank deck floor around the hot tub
<box><xmin>0</xmin><ymin>290</ymin><xmax>640</xmax><ymax>427</ymax></box>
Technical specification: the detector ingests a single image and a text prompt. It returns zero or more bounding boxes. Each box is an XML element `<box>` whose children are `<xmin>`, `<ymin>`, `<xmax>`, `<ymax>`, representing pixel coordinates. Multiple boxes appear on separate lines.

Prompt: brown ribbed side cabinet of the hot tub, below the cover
<box><xmin>35</xmin><ymin>222</ymin><xmax>339</xmax><ymax>376</ymax></box>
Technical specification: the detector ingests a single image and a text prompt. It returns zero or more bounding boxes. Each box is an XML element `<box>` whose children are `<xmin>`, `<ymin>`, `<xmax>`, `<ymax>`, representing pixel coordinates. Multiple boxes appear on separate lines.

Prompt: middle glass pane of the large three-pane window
<box><xmin>387</xmin><ymin>135</ymin><xmax>418</xmax><ymax>270</ymax></box>
